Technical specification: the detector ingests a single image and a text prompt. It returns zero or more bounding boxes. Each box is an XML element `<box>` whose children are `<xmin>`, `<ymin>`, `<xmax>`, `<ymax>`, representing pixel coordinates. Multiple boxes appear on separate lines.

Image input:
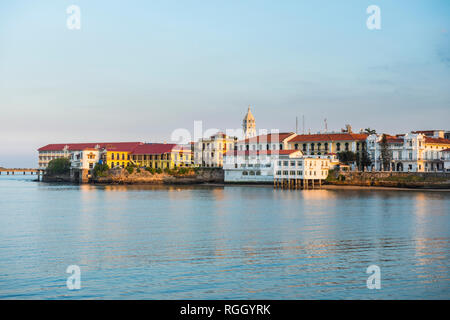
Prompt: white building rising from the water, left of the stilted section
<box><xmin>223</xmin><ymin>150</ymin><xmax>302</xmax><ymax>183</ymax></box>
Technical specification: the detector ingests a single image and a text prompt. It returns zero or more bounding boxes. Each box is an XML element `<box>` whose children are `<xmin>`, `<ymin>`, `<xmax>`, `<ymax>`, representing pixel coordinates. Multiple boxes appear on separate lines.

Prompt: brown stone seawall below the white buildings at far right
<box><xmin>326</xmin><ymin>171</ymin><xmax>450</xmax><ymax>189</ymax></box>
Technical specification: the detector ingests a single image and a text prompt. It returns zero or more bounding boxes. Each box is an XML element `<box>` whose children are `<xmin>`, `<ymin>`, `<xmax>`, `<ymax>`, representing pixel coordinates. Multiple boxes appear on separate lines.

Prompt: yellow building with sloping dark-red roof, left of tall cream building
<box><xmin>131</xmin><ymin>143</ymin><xmax>192</xmax><ymax>169</ymax></box>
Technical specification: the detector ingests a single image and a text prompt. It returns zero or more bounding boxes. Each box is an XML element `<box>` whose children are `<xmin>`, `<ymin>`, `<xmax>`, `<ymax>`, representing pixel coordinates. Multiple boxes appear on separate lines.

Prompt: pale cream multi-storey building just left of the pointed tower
<box><xmin>193</xmin><ymin>132</ymin><xmax>237</xmax><ymax>167</ymax></box>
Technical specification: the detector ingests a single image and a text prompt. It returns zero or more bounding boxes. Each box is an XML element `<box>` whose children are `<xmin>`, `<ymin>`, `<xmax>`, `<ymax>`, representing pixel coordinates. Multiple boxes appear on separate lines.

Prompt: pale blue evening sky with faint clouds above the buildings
<box><xmin>0</xmin><ymin>0</ymin><xmax>450</xmax><ymax>167</ymax></box>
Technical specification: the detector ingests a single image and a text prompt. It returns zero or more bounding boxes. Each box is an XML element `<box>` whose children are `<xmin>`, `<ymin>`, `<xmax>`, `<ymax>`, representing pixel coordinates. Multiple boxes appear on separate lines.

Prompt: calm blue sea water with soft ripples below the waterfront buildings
<box><xmin>0</xmin><ymin>175</ymin><xmax>450</xmax><ymax>299</ymax></box>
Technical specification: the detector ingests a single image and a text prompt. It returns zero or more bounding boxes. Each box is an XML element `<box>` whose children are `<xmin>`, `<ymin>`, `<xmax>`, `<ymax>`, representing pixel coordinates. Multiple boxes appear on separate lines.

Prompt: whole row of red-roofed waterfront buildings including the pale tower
<box><xmin>38</xmin><ymin>107</ymin><xmax>450</xmax><ymax>188</ymax></box>
